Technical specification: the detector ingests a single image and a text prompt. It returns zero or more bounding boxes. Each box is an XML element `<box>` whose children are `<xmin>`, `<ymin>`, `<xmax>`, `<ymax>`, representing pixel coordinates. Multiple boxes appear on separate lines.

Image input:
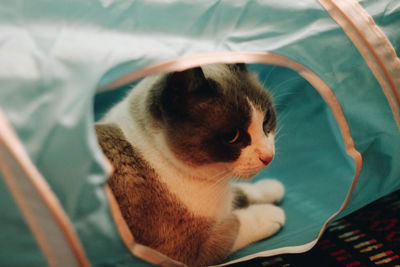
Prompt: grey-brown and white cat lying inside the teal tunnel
<box><xmin>95</xmin><ymin>64</ymin><xmax>285</xmax><ymax>266</ymax></box>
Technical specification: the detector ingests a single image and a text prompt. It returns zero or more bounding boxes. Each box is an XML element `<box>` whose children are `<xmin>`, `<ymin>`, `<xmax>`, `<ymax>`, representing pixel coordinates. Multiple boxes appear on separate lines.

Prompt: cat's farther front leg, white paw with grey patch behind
<box><xmin>232</xmin><ymin>179</ymin><xmax>285</xmax><ymax>208</ymax></box>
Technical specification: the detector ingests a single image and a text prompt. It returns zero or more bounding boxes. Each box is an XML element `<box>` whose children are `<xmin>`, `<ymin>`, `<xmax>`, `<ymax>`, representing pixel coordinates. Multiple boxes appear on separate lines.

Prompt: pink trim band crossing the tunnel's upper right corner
<box><xmin>319</xmin><ymin>0</ymin><xmax>400</xmax><ymax>131</ymax></box>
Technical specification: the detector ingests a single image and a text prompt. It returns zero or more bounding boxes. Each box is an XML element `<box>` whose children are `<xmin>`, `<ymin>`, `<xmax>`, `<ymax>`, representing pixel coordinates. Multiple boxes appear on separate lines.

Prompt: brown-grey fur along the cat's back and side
<box><xmin>96</xmin><ymin>125</ymin><xmax>239</xmax><ymax>266</ymax></box>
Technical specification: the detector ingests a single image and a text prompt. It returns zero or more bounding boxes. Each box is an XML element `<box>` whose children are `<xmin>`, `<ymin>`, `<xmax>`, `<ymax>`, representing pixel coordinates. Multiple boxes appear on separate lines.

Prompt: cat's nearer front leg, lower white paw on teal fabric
<box><xmin>231</xmin><ymin>204</ymin><xmax>285</xmax><ymax>253</ymax></box>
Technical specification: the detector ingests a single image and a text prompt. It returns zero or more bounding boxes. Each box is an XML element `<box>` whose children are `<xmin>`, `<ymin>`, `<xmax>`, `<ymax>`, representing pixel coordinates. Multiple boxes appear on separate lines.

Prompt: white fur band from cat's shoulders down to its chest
<box><xmin>101</xmin><ymin>85</ymin><xmax>232</xmax><ymax>220</ymax></box>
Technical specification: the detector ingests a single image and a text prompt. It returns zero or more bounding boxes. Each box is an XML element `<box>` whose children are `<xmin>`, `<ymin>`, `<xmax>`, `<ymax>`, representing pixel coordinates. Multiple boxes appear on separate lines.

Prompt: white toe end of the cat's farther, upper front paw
<box><xmin>253</xmin><ymin>179</ymin><xmax>285</xmax><ymax>203</ymax></box>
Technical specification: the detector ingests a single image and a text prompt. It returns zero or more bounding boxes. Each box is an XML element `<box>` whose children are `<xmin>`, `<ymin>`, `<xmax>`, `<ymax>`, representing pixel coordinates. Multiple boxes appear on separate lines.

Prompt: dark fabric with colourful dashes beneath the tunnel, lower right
<box><xmin>231</xmin><ymin>191</ymin><xmax>400</xmax><ymax>267</ymax></box>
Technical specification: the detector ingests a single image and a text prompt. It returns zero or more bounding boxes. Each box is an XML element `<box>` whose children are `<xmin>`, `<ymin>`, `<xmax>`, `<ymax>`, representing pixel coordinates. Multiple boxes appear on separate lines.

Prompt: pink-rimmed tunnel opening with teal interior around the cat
<box><xmin>94</xmin><ymin>52</ymin><xmax>361</xmax><ymax>263</ymax></box>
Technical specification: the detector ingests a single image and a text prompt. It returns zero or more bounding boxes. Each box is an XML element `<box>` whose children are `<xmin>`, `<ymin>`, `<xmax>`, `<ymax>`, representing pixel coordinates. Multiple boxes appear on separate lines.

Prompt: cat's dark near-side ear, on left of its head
<box><xmin>167</xmin><ymin>67</ymin><xmax>207</xmax><ymax>95</ymax></box>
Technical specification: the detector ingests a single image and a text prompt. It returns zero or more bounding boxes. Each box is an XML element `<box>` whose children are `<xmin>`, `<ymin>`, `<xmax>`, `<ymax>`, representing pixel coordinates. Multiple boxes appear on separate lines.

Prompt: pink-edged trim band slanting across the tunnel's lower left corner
<box><xmin>0</xmin><ymin>110</ymin><xmax>90</xmax><ymax>266</ymax></box>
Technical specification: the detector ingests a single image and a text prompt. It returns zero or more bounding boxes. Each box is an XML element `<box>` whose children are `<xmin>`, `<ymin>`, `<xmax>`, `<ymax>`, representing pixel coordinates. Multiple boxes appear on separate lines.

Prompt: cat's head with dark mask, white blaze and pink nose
<box><xmin>151</xmin><ymin>64</ymin><xmax>276</xmax><ymax>178</ymax></box>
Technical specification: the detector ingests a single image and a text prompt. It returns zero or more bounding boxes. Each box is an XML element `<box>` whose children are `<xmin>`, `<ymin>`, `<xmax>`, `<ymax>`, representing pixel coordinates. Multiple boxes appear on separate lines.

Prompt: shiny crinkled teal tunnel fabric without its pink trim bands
<box><xmin>0</xmin><ymin>0</ymin><xmax>400</xmax><ymax>266</ymax></box>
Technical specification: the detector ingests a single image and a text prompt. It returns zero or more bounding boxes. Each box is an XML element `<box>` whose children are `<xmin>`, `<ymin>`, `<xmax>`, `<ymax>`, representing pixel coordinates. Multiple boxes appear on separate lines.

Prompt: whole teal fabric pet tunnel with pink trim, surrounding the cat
<box><xmin>0</xmin><ymin>0</ymin><xmax>400</xmax><ymax>266</ymax></box>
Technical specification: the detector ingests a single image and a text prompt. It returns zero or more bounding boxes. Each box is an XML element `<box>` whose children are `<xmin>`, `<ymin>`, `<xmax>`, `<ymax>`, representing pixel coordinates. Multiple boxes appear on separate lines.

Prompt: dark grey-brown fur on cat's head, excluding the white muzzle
<box><xmin>145</xmin><ymin>64</ymin><xmax>276</xmax><ymax>166</ymax></box>
